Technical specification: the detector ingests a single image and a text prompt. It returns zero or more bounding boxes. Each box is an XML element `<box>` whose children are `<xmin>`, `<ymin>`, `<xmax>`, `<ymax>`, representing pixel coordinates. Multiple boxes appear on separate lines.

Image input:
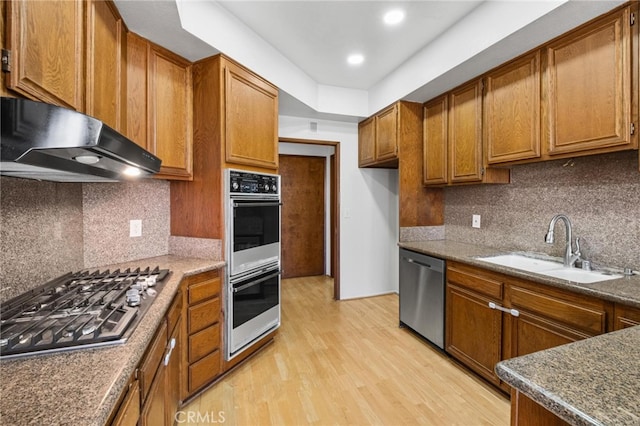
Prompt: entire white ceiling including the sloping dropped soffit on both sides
<box><xmin>115</xmin><ymin>0</ymin><xmax>623</xmax><ymax>121</ymax></box>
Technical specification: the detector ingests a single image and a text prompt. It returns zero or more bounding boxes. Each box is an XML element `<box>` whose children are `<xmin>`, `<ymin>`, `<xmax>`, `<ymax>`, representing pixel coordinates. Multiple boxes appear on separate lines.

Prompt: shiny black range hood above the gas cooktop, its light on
<box><xmin>0</xmin><ymin>97</ymin><xmax>161</xmax><ymax>182</ymax></box>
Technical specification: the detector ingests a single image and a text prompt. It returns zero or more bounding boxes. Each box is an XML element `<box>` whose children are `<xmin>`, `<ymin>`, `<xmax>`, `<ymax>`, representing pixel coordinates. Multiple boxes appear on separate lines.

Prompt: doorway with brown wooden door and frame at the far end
<box><xmin>279</xmin><ymin>138</ymin><xmax>340</xmax><ymax>300</ymax></box>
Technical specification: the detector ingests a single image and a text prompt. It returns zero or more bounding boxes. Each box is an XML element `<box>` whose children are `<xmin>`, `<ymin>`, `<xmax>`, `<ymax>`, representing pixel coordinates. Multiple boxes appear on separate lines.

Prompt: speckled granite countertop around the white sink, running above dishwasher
<box><xmin>398</xmin><ymin>240</ymin><xmax>640</xmax><ymax>308</ymax></box>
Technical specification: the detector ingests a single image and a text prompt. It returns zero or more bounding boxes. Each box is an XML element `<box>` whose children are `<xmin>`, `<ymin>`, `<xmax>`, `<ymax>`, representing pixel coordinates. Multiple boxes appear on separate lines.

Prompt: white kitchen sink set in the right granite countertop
<box><xmin>476</xmin><ymin>253</ymin><xmax>623</xmax><ymax>284</ymax></box>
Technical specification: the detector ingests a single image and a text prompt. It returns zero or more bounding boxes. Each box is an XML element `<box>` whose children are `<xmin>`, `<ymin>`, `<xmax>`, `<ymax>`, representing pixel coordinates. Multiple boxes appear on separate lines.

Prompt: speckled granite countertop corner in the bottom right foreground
<box><xmin>496</xmin><ymin>326</ymin><xmax>640</xmax><ymax>426</ymax></box>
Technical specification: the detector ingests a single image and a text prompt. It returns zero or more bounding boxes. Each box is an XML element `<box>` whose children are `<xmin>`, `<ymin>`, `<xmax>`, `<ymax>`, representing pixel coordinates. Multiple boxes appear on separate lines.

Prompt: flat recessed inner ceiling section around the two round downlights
<box><xmin>214</xmin><ymin>0</ymin><xmax>481</xmax><ymax>90</ymax></box>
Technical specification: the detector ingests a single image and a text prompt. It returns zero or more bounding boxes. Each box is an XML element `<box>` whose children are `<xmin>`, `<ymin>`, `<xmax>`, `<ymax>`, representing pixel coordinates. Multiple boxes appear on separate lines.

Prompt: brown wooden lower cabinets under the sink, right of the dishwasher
<box><xmin>445</xmin><ymin>262</ymin><xmax>616</xmax><ymax>392</ymax></box>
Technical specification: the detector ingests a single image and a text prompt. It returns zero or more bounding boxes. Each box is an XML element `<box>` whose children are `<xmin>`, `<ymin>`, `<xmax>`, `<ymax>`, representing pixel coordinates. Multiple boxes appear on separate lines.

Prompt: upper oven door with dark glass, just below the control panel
<box><xmin>230</xmin><ymin>199</ymin><xmax>281</xmax><ymax>275</ymax></box>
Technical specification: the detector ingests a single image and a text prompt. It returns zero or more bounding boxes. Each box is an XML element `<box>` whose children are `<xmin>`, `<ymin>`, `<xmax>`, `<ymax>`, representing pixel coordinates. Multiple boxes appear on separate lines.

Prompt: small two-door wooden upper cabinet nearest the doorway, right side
<box><xmin>358</xmin><ymin>103</ymin><xmax>402</xmax><ymax>168</ymax></box>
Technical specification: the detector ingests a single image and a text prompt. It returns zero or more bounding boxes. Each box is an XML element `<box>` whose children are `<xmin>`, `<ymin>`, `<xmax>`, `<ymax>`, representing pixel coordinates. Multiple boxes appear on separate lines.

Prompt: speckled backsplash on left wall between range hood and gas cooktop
<box><xmin>0</xmin><ymin>177</ymin><xmax>83</xmax><ymax>300</ymax></box>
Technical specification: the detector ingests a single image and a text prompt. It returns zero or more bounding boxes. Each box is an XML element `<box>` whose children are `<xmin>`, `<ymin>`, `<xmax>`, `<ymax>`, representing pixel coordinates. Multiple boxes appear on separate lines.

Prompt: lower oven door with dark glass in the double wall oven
<box><xmin>228</xmin><ymin>266</ymin><xmax>280</xmax><ymax>356</ymax></box>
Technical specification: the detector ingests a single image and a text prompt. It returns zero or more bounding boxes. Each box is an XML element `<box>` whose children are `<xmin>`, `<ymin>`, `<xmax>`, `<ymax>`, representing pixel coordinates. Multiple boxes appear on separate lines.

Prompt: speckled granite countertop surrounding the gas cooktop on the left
<box><xmin>0</xmin><ymin>256</ymin><xmax>224</xmax><ymax>426</ymax></box>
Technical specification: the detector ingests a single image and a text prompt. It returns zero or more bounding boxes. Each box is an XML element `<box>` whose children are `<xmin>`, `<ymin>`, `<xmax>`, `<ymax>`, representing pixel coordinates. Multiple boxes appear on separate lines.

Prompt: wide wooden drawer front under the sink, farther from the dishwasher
<box><xmin>509</xmin><ymin>286</ymin><xmax>607</xmax><ymax>335</ymax></box>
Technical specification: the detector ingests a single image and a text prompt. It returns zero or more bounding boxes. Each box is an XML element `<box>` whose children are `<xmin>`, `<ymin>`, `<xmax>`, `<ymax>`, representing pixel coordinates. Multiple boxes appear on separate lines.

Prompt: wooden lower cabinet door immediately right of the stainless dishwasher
<box><xmin>445</xmin><ymin>284</ymin><xmax>502</xmax><ymax>385</ymax></box>
